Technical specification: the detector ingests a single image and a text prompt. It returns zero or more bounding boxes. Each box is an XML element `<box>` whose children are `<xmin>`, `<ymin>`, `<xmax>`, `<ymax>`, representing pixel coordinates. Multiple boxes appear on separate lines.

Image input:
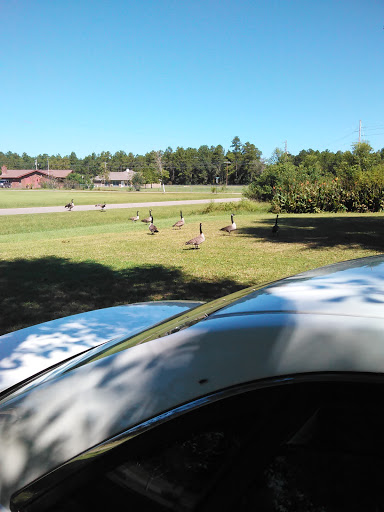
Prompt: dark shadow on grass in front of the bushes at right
<box><xmin>237</xmin><ymin>215</ymin><xmax>384</xmax><ymax>251</ymax></box>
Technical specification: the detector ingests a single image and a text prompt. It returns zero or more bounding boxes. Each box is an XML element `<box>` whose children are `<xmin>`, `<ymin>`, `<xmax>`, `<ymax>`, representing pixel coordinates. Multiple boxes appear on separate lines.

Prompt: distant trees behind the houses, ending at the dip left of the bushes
<box><xmin>0</xmin><ymin>137</ymin><xmax>264</xmax><ymax>185</ymax></box>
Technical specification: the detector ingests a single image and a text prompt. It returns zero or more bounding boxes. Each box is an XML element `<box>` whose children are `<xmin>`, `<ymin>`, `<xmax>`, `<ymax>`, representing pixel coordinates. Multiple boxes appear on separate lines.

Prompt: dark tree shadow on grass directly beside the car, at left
<box><xmin>0</xmin><ymin>257</ymin><xmax>247</xmax><ymax>334</ymax></box>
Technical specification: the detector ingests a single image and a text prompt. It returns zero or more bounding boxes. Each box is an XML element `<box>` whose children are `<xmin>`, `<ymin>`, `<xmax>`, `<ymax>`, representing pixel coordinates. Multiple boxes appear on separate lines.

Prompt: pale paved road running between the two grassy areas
<box><xmin>0</xmin><ymin>197</ymin><xmax>241</xmax><ymax>215</ymax></box>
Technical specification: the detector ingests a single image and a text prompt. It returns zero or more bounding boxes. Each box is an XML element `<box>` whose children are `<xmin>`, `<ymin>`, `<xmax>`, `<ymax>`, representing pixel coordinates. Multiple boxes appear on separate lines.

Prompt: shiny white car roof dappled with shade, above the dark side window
<box><xmin>0</xmin><ymin>257</ymin><xmax>384</xmax><ymax>503</ymax></box>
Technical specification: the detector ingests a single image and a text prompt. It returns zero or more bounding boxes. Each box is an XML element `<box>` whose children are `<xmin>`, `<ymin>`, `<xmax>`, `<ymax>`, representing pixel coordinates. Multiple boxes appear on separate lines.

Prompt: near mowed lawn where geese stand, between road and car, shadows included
<box><xmin>0</xmin><ymin>200</ymin><xmax>384</xmax><ymax>334</ymax></box>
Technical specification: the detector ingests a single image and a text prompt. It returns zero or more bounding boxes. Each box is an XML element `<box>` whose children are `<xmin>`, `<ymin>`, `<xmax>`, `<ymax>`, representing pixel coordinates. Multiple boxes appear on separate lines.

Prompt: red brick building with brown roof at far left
<box><xmin>0</xmin><ymin>165</ymin><xmax>72</xmax><ymax>188</ymax></box>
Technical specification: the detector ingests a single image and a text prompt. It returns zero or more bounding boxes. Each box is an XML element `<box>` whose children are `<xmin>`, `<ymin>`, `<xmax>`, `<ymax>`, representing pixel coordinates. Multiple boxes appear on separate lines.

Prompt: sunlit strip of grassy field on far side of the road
<box><xmin>0</xmin><ymin>185</ymin><xmax>242</xmax><ymax>208</ymax></box>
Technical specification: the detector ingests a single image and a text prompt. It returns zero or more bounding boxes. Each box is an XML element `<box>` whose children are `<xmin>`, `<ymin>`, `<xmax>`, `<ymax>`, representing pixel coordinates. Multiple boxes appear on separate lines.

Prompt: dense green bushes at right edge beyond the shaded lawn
<box><xmin>245</xmin><ymin>142</ymin><xmax>384</xmax><ymax>213</ymax></box>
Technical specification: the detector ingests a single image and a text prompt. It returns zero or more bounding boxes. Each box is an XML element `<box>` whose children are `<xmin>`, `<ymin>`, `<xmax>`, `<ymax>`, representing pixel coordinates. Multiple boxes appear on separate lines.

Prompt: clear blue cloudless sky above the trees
<box><xmin>0</xmin><ymin>0</ymin><xmax>384</xmax><ymax>158</ymax></box>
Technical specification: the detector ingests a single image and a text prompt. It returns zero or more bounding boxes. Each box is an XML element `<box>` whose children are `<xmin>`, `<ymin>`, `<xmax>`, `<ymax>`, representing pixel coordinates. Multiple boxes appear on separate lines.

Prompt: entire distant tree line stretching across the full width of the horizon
<box><xmin>0</xmin><ymin>136</ymin><xmax>384</xmax><ymax>190</ymax></box>
